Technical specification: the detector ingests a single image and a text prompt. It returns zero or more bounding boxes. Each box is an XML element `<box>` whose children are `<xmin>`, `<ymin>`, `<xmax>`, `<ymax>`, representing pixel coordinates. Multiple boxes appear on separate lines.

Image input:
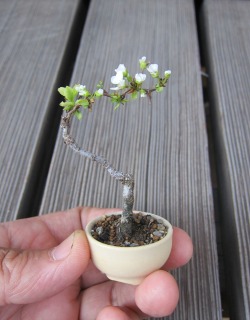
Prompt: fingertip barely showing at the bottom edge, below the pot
<box><xmin>96</xmin><ymin>306</ymin><xmax>140</xmax><ymax>320</ymax></box>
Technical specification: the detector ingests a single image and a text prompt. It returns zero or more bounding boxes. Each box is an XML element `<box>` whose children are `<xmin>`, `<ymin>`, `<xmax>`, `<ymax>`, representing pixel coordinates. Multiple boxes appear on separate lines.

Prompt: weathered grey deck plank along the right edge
<box><xmin>201</xmin><ymin>0</ymin><xmax>250</xmax><ymax>320</ymax></box>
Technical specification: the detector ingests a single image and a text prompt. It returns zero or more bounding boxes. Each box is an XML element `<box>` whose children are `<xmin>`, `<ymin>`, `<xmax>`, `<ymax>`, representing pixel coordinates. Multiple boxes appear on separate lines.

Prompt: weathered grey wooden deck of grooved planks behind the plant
<box><xmin>0</xmin><ymin>0</ymin><xmax>250</xmax><ymax>320</ymax></box>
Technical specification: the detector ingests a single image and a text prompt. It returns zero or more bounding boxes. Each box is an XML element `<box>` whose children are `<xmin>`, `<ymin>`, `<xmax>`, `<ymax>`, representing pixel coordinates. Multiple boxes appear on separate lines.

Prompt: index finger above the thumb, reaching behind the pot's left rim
<box><xmin>0</xmin><ymin>207</ymin><xmax>117</xmax><ymax>249</ymax></box>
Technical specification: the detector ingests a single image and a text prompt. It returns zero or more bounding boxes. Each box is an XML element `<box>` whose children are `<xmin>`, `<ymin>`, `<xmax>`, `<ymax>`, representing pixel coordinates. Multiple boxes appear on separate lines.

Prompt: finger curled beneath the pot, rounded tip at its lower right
<box><xmin>80</xmin><ymin>270</ymin><xmax>179</xmax><ymax>320</ymax></box>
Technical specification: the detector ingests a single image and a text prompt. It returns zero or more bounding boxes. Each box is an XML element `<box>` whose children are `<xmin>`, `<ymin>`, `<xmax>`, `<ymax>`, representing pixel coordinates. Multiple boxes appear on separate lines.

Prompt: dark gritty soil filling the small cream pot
<box><xmin>91</xmin><ymin>212</ymin><xmax>168</xmax><ymax>247</ymax></box>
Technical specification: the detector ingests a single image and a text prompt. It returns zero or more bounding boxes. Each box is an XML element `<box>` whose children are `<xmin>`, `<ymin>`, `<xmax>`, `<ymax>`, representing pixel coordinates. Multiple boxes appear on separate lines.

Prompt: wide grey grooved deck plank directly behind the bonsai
<box><xmin>41</xmin><ymin>0</ymin><xmax>221</xmax><ymax>320</ymax></box>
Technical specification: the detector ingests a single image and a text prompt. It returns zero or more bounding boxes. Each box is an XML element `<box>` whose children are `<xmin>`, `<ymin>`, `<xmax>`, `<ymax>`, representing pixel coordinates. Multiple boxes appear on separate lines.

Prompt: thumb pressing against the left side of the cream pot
<box><xmin>0</xmin><ymin>230</ymin><xmax>90</xmax><ymax>305</ymax></box>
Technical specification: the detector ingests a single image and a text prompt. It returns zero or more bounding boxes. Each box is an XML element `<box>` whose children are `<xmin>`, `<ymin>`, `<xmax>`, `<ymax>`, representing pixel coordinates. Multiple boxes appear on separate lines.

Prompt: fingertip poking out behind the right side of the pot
<box><xmin>163</xmin><ymin>227</ymin><xmax>193</xmax><ymax>270</ymax></box>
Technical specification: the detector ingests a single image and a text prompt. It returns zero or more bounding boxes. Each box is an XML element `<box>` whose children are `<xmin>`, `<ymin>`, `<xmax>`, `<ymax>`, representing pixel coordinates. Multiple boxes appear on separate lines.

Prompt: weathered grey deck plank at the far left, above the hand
<box><xmin>0</xmin><ymin>0</ymin><xmax>84</xmax><ymax>221</ymax></box>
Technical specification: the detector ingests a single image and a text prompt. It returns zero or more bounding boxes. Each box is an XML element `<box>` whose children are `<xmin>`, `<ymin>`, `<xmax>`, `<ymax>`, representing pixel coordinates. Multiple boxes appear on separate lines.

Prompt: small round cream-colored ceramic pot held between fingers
<box><xmin>85</xmin><ymin>211</ymin><xmax>173</xmax><ymax>285</ymax></box>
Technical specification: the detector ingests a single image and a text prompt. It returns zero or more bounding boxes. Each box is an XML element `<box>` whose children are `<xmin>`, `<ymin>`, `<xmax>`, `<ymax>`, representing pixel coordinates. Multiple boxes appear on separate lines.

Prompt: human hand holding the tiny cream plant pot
<box><xmin>0</xmin><ymin>207</ymin><xmax>193</xmax><ymax>320</ymax></box>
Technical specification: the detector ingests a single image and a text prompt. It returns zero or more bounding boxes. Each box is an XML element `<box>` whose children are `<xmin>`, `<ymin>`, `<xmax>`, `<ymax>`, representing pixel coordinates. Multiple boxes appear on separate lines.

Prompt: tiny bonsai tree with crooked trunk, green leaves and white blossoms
<box><xmin>58</xmin><ymin>57</ymin><xmax>171</xmax><ymax>241</ymax></box>
